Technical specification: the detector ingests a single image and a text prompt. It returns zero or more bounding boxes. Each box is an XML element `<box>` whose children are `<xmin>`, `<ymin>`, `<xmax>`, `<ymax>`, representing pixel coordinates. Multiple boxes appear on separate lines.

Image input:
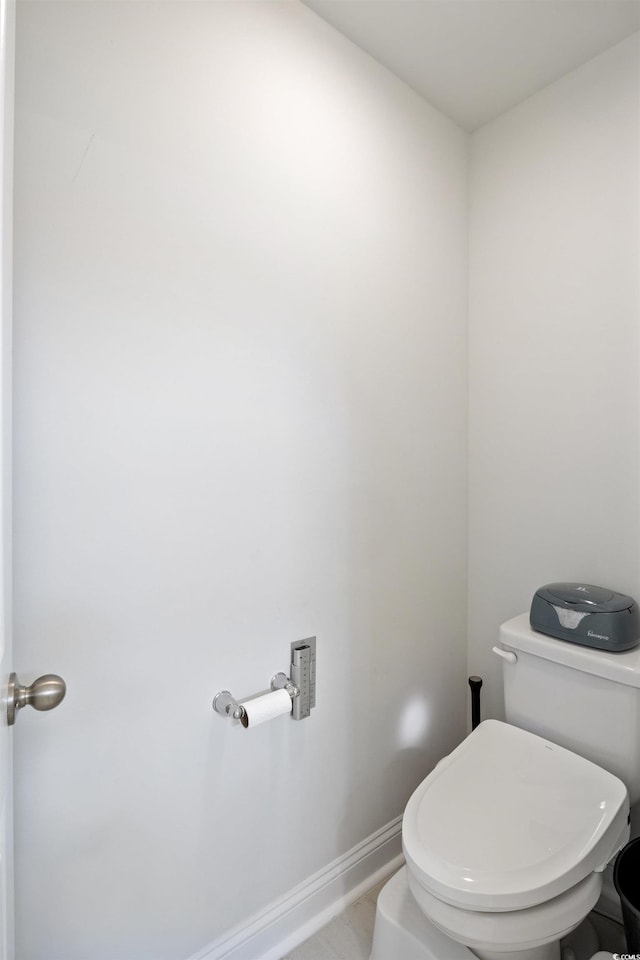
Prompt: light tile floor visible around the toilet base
<box><xmin>282</xmin><ymin>879</ymin><xmax>626</xmax><ymax>960</ymax></box>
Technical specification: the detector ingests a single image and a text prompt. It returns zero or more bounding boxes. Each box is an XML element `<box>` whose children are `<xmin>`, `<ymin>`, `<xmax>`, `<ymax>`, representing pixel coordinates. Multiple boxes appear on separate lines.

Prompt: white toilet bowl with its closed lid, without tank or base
<box><xmin>402</xmin><ymin>720</ymin><xmax>629</xmax><ymax>960</ymax></box>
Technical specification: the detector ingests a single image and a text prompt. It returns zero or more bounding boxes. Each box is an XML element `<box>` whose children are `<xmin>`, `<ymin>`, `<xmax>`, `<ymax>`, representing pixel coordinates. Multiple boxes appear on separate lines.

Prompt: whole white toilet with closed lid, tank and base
<box><xmin>371</xmin><ymin>614</ymin><xmax>640</xmax><ymax>960</ymax></box>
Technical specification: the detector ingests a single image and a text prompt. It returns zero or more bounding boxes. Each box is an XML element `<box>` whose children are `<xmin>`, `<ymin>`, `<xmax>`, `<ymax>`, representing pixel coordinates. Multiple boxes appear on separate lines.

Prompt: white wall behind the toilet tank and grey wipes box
<box><xmin>468</xmin><ymin>35</ymin><xmax>640</xmax><ymax>716</ymax></box>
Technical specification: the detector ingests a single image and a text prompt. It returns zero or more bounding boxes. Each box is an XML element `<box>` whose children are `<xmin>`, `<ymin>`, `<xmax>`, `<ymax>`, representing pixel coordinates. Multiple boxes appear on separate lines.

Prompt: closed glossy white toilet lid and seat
<box><xmin>402</xmin><ymin>720</ymin><xmax>629</xmax><ymax>911</ymax></box>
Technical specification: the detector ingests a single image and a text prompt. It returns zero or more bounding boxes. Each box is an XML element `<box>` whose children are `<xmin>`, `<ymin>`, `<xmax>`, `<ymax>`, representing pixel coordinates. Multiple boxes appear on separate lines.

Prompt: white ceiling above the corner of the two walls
<box><xmin>303</xmin><ymin>0</ymin><xmax>640</xmax><ymax>130</ymax></box>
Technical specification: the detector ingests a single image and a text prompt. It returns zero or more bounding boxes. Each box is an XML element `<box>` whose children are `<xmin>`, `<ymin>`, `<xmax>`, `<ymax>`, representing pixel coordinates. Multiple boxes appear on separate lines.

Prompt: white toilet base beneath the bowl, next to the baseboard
<box><xmin>370</xmin><ymin>867</ymin><xmax>611</xmax><ymax>960</ymax></box>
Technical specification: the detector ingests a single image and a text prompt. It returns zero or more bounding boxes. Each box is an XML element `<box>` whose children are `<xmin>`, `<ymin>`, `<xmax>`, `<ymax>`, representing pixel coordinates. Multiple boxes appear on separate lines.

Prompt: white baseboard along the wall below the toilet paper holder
<box><xmin>189</xmin><ymin>817</ymin><xmax>404</xmax><ymax>960</ymax></box>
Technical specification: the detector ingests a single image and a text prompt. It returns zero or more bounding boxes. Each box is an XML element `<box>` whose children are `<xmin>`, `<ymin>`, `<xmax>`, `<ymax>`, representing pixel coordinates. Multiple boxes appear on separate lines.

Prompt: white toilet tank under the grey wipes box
<box><xmin>500</xmin><ymin>613</ymin><xmax>640</xmax><ymax>803</ymax></box>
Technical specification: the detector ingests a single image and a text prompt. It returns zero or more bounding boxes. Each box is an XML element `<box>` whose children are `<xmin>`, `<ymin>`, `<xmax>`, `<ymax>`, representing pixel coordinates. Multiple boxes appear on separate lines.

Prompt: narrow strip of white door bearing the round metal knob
<box><xmin>0</xmin><ymin>0</ymin><xmax>15</xmax><ymax>960</ymax></box>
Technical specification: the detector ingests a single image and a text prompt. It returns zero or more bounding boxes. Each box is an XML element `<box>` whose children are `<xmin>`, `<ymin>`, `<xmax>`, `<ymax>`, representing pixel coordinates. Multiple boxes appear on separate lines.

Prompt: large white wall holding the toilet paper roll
<box><xmin>15</xmin><ymin>0</ymin><xmax>470</xmax><ymax>960</ymax></box>
